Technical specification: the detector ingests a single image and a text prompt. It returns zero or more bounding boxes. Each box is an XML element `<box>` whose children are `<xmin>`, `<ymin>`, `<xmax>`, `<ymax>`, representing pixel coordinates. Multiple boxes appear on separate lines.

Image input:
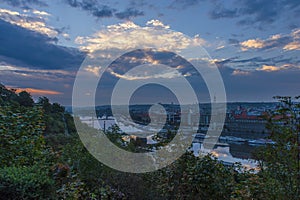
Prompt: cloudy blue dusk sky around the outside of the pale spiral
<box><xmin>0</xmin><ymin>0</ymin><xmax>300</xmax><ymax>105</ymax></box>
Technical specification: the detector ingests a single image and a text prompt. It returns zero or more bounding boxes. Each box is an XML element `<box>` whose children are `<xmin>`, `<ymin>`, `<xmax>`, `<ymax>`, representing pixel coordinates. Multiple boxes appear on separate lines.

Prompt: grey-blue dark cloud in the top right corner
<box><xmin>168</xmin><ymin>0</ymin><xmax>300</xmax><ymax>29</ymax></box>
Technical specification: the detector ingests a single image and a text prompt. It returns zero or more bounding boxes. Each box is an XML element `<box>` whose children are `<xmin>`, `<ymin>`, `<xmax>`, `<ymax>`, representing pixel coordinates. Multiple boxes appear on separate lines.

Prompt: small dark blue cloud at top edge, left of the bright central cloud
<box><xmin>65</xmin><ymin>0</ymin><xmax>144</xmax><ymax>19</ymax></box>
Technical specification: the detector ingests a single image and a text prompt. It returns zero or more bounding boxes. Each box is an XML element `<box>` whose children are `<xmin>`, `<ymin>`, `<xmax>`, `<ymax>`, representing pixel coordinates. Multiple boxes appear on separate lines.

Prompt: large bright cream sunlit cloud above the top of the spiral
<box><xmin>75</xmin><ymin>20</ymin><xmax>205</xmax><ymax>52</ymax></box>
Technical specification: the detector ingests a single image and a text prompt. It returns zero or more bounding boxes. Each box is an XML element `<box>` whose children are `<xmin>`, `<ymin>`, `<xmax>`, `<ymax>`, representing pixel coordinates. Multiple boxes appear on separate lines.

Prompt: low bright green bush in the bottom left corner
<box><xmin>0</xmin><ymin>165</ymin><xmax>54</xmax><ymax>199</ymax></box>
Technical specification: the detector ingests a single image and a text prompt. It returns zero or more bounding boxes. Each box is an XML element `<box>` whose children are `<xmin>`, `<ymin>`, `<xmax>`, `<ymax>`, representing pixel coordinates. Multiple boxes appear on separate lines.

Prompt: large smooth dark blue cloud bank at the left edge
<box><xmin>0</xmin><ymin>20</ymin><xmax>85</xmax><ymax>69</ymax></box>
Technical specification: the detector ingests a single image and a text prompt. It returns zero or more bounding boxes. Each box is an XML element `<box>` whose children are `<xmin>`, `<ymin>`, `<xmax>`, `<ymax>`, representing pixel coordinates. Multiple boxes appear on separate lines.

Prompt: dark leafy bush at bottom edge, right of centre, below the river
<box><xmin>145</xmin><ymin>152</ymin><xmax>236</xmax><ymax>199</ymax></box>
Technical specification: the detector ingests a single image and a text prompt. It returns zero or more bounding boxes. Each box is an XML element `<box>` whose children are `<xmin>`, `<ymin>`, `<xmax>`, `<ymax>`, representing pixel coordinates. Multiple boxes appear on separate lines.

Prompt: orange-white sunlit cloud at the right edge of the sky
<box><xmin>240</xmin><ymin>29</ymin><xmax>300</xmax><ymax>51</ymax></box>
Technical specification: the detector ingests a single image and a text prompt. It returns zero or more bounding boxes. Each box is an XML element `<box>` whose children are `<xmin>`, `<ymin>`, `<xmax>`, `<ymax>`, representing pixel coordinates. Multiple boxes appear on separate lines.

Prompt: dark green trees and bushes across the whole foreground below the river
<box><xmin>0</xmin><ymin>85</ymin><xmax>300</xmax><ymax>200</ymax></box>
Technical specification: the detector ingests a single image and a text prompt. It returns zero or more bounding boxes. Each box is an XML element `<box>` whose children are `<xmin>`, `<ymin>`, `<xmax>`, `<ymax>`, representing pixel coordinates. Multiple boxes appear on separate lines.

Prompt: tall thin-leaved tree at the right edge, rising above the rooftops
<box><xmin>256</xmin><ymin>97</ymin><xmax>300</xmax><ymax>199</ymax></box>
